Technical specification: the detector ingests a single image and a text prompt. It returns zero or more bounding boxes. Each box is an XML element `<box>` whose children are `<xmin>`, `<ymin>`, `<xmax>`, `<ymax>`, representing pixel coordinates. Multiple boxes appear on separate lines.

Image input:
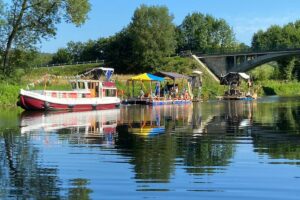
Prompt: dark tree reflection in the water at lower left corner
<box><xmin>0</xmin><ymin>128</ymin><xmax>60</xmax><ymax>199</ymax></box>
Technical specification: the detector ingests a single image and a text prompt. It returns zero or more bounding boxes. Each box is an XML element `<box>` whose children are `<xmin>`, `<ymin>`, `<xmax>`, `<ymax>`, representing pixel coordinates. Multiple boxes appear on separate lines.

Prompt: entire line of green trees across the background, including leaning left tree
<box><xmin>0</xmin><ymin>0</ymin><xmax>300</xmax><ymax>80</ymax></box>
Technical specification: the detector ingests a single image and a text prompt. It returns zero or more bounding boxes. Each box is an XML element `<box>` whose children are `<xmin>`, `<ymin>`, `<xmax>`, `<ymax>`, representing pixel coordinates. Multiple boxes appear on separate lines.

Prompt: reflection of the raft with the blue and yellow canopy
<box><xmin>120</xmin><ymin>105</ymin><xmax>197</xmax><ymax>137</ymax></box>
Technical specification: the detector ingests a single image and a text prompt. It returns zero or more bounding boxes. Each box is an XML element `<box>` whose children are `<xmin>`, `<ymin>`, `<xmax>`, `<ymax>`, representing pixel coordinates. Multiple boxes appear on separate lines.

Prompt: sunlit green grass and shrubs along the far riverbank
<box><xmin>0</xmin><ymin>57</ymin><xmax>300</xmax><ymax>108</ymax></box>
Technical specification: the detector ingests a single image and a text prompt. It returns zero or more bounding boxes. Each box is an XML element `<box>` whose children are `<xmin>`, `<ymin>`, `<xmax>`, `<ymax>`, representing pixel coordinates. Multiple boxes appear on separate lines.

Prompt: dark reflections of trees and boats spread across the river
<box><xmin>0</xmin><ymin>99</ymin><xmax>300</xmax><ymax>199</ymax></box>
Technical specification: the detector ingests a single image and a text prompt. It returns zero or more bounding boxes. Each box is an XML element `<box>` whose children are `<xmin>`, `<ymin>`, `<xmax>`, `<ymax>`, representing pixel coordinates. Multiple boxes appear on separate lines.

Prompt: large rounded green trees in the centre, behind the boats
<box><xmin>52</xmin><ymin>5</ymin><xmax>237</xmax><ymax>73</ymax></box>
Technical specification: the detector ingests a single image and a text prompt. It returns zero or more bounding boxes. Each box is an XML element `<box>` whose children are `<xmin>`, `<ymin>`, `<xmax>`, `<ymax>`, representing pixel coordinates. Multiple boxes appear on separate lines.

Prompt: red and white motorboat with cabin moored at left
<box><xmin>17</xmin><ymin>67</ymin><xmax>120</xmax><ymax>110</ymax></box>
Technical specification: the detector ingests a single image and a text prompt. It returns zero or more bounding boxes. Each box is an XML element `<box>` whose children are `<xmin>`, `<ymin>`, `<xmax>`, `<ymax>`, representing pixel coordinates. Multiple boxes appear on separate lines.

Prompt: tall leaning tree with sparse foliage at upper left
<box><xmin>0</xmin><ymin>0</ymin><xmax>90</xmax><ymax>74</ymax></box>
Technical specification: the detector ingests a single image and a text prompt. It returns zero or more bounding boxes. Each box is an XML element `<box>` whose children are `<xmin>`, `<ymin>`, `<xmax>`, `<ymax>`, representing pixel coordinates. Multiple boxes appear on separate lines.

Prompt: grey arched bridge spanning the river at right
<box><xmin>193</xmin><ymin>48</ymin><xmax>300</xmax><ymax>77</ymax></box>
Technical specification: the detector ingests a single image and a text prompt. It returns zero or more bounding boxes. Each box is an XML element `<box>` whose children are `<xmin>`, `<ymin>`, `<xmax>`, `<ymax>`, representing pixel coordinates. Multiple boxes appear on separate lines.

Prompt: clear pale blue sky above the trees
<box><xmin>40</xmin><ymin>0</ymin><xmax>300</xmax><ymax>52</ymax></box>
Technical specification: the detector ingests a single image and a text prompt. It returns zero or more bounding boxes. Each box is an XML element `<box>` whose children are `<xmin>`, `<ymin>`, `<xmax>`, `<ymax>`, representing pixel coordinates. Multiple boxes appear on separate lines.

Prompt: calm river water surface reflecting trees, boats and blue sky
<box><xmin>0</xmin><ymin>97</ymin><xmax>300</xmax><ymax>199</ymax></box>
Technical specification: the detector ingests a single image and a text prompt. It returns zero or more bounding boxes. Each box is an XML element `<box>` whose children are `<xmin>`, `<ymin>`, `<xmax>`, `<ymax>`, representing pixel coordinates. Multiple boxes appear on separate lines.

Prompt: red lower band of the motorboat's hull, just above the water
<box><xmin>20</xmin><ymin>95</ymin><xmax>119</xmax><ymax>111</ymax></box>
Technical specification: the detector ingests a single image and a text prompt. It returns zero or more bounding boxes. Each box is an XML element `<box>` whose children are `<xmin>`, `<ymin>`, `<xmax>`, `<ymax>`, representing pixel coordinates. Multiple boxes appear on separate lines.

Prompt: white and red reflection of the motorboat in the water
<box><xmin>21</xmin><ymin>109</ymin><xmax>120</xmax><ymax>146</ymax></box>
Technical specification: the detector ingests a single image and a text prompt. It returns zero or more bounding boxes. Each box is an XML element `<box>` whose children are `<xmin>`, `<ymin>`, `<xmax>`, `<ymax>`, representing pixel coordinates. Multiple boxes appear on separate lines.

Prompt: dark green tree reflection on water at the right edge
<box><xmin>252</xmin><ymin>101</ymin><xmax>300</xmax><ymax>162</ymax></box>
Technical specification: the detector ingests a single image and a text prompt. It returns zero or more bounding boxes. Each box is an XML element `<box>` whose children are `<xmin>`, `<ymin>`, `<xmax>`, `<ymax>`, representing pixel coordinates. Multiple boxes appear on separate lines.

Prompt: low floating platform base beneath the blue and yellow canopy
<box><xmin>122</xmin><ymin>98</ymin><xmax>192</xmax><ymax>105</ymax></box>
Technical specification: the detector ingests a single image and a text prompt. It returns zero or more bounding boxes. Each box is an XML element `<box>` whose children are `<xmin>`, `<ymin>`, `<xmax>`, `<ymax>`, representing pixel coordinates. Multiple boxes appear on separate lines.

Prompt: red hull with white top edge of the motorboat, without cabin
<box><xmin>18</xmin><ymin>94</ymin><xmax>120</xmax><ymax>111</ymax></box>
